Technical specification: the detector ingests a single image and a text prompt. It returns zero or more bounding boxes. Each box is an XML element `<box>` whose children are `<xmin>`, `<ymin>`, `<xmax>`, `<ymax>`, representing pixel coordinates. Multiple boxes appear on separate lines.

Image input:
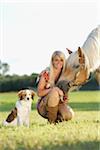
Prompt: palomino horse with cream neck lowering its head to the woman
<box><xmin>59</xmin><ymin>25</ymin><xmax>100</xmax><ymax>87</ymax></box>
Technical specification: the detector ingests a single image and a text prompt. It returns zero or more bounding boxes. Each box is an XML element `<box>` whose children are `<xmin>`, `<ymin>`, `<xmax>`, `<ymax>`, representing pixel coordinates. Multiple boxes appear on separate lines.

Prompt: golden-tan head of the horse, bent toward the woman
<box><xmin>60</xmin><ymin>47</ymin><xmax>89</xmax><ymax>86</ymax></box>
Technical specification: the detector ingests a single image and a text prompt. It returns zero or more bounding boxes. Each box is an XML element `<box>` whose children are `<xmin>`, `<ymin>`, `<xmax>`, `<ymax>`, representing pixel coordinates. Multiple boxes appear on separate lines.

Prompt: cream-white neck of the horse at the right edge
<box><xmin>82</xmin><ymin>27</ymin><xmax>100</xmax><ymax>72</ymax></box>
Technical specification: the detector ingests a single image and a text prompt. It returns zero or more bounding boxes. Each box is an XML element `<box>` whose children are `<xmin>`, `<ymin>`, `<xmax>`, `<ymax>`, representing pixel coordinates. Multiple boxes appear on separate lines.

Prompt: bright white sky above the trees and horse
<box><xmin>0</xmin><ymin>0</ymin><xmax>100</xmax><ymax>75</ymax></box>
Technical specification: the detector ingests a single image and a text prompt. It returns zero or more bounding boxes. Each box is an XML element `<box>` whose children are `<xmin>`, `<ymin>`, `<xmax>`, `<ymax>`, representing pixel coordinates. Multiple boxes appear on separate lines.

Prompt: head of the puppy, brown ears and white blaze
<box><xmin>18</xmin><ymin>89</ymin><xmax>35</xmax><ymax>101</ymax></box>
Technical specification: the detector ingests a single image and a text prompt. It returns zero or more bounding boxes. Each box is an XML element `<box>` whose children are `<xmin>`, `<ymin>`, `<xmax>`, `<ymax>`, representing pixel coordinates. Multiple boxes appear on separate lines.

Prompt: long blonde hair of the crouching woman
<box><xmin>49</xmin><ymin>51</ymin><xmax>66</xmax><ymax>86</ymax></box>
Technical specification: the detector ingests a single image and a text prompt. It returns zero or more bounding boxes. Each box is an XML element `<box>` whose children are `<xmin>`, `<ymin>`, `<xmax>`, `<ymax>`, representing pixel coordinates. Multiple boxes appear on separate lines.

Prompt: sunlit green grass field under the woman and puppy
<box><xmin>0</xmin><ymin>91</ymin><xmax>100</xmax><ymax>150</ymax></box>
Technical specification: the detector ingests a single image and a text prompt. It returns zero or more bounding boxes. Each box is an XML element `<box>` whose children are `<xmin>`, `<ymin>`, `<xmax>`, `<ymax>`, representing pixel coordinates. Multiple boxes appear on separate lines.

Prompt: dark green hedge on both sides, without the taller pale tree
<box><xmin>0</xmin><ymin>73</ymin><xmax>100</xmax><ymax>92</ymax></box>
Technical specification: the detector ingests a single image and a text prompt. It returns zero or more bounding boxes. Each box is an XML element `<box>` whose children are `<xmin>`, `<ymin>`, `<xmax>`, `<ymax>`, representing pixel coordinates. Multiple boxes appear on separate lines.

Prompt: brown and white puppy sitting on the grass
<box><xmin>3</xmin><ymin>89</ymin><xmax>35</xmax><ymax>127</ymax></box>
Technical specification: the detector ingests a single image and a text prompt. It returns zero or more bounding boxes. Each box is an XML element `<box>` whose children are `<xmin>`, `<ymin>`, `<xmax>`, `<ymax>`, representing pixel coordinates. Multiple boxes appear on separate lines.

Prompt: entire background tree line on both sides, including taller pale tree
<box><xmin>0</xmin><ymin>61</ymin><xmax>100</xmax><ymax>92</ymax></box>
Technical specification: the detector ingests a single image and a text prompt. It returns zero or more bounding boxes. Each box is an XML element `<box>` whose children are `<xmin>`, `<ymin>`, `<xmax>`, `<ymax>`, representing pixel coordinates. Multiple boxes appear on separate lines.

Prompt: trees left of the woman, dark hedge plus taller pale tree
<box><xmin>0</xmin><ymin>60</ymin><xmax>38</xmax><ymax>92</ymax></box>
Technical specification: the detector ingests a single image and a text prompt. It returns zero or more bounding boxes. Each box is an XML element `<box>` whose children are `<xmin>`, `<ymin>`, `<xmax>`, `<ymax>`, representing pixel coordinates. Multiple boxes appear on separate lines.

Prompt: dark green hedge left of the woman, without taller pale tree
<box><xmin>0</xmin><ymin>74</ymin><xmax>37</xmax><ymax>92</ymax></box>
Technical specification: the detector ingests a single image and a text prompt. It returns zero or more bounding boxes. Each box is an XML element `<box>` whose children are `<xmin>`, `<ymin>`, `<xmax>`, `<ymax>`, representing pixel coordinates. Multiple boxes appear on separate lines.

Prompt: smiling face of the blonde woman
<box><xmin>52</xmin><ymin>55</ymin><xmax>64</xmax><ymax>69</ymax></box>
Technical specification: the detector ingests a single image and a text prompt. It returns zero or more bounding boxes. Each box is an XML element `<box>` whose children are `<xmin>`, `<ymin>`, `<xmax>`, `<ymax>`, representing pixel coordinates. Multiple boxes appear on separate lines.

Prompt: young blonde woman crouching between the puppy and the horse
<box><xmin>37</xmin><ymin>51</ymin><xmax>74</xmax><ymax>123</ymax></box>
